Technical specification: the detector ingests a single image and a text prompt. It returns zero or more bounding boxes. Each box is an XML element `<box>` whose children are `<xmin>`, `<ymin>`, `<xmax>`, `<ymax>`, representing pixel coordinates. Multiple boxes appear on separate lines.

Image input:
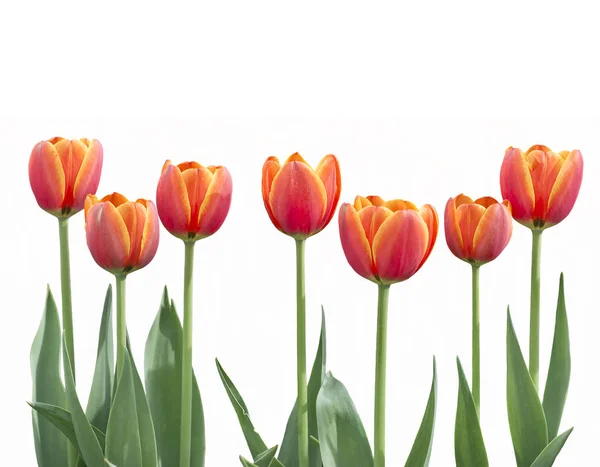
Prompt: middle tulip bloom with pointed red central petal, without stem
<box><xmin>262</xmin><ymin>153</ymin><xmax>342</xmax><ymax>240</ymax></box>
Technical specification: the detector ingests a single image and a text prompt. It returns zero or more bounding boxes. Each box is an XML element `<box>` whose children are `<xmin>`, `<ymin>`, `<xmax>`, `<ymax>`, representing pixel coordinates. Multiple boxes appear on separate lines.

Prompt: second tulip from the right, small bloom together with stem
<box><xmin>444</xmin><ymin>194</ymin><xmax>512</xmax><ymax>413</ymax></box>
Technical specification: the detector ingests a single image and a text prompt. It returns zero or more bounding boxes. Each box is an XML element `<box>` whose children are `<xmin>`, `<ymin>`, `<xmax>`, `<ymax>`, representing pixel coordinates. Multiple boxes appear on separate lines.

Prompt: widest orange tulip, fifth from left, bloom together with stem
<box><xmin>339</xmin><ymin>196</ymin><xmax>438</xmax><ymax>467</ymax></box>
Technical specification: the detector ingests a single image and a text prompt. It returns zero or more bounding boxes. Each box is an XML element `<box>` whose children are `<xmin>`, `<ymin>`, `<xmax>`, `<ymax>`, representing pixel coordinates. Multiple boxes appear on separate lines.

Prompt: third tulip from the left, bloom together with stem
<box><xmin>156</xmin><ymin>160</ymin><xmax>232</xmax><ymax>467</ymax></box>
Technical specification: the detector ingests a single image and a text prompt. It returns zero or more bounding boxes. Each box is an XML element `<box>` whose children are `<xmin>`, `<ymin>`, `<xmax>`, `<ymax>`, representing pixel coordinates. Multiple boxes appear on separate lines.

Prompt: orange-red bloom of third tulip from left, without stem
<box><xmin>156</xmin><ymin>161</ymin><xmax>232</xmax><ymax>241</ymax></box>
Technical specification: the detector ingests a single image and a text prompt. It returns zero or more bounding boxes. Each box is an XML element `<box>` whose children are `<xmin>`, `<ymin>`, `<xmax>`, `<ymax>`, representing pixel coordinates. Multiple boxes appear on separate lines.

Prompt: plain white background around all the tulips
<box><xmin>0</xmin><ymin>2</ymin><xmax>600</xmax><ymax>467</ymax></box>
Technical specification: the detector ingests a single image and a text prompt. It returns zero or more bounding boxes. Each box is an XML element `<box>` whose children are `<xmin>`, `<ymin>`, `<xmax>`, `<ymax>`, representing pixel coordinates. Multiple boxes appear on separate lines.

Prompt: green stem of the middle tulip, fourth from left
<box><xmin>296</xmin><ymin>240</ymin><xmax>308</xmax><ymax>467</ymax></box>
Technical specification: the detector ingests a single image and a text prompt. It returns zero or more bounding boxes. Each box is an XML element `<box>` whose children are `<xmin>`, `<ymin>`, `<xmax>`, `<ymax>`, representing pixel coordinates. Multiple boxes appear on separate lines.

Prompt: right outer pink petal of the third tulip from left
<box><xmin>198</xmin><ymin>167</ymin><xmax>232</xmax><ymax>237</ymax></box>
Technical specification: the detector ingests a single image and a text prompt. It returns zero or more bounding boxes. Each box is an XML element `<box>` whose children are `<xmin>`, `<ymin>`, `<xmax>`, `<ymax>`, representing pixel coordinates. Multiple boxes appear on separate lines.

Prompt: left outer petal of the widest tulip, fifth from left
<box><xmin>338</xmin><ymin>203</ymin><xmax>377</xmax><ymax>282</ymax></box>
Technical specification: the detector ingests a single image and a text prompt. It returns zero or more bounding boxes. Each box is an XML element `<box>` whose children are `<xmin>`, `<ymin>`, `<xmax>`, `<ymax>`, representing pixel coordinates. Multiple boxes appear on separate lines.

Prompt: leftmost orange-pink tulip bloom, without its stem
<box><xmin>29</xmin><ymin>137</ymin><xmax>103</xmax><ymax>218</ymax></box>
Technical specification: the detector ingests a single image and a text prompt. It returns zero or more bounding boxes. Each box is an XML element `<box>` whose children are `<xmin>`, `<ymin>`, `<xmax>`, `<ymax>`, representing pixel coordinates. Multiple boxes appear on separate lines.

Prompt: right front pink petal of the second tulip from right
<box><xmin>473</xmin><ymin>203</ymin><xmax>512</xmax><ymax>263</ymax></box>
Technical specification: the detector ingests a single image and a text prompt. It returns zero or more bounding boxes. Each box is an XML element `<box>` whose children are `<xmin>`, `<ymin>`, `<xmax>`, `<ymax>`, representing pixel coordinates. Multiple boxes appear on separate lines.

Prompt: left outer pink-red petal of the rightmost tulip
<box><xmin>500</xmin><ymin>148</ymin><xmax>535</xmax><ymax>225</ymax></box>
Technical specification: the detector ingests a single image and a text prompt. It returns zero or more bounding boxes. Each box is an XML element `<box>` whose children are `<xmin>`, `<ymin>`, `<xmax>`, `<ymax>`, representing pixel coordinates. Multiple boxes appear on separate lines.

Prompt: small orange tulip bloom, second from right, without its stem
<box><xmin>444</xmin><ymin>194</ymin><xmax>512</xmax><ymax>265</ymax></box>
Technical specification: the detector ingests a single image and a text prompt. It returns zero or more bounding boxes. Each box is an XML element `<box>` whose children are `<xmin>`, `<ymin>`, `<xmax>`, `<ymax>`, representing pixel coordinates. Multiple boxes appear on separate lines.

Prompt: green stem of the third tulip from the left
<box><xmin>179</xmin><ymin>242</ymin><xmax>195</xmax><ymax>467</ymax></box>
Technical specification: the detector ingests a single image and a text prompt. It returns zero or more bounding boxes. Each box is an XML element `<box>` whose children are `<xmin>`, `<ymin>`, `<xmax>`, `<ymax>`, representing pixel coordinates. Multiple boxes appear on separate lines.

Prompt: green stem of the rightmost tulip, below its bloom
<box><xmin>529</xmin><ymin>230</ymin><xmax>542</xmax><ymax>388</ymax></box>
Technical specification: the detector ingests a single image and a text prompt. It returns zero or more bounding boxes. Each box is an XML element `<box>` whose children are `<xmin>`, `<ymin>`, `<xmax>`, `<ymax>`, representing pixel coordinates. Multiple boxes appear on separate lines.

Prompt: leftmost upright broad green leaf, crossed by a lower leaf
<box><xmin>29</xmin><ymin>287</ymin><xmax>68</xmax><ymax>467</ymax></box>
